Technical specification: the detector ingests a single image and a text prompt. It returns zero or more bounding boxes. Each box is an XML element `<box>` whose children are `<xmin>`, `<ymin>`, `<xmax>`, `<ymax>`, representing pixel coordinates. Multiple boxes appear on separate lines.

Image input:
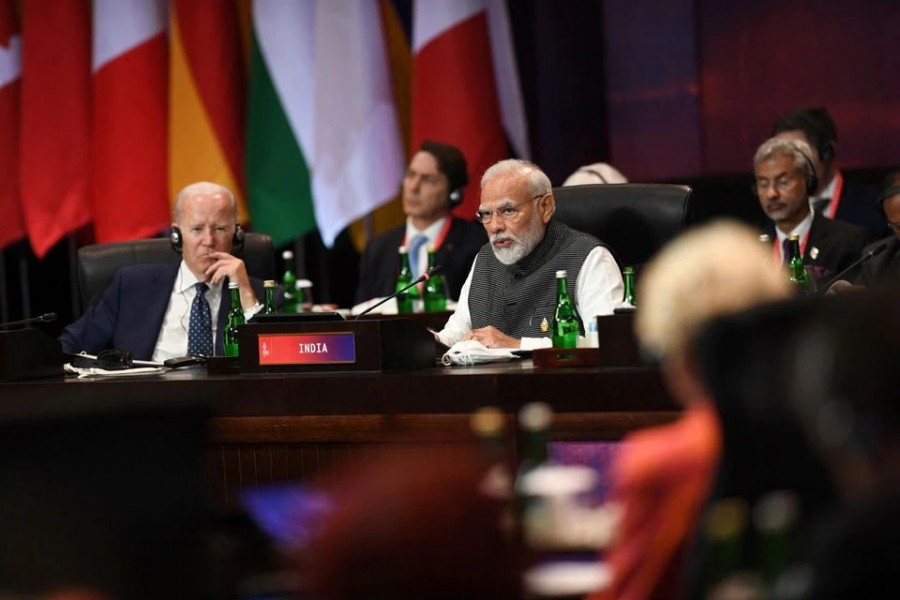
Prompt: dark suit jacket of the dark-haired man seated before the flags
<box><xmin>356</xmin><ymin>217</ymin><xmax>487</xmax><ymax>303</ymax></box>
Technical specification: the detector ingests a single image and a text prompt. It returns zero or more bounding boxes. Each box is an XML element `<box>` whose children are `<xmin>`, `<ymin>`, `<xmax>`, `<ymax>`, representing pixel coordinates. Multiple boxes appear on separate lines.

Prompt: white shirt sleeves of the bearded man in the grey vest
<box><xmin>438</xmin><ymin>246</ymin><xmax>625</xmax><ymax>350</ymax></box>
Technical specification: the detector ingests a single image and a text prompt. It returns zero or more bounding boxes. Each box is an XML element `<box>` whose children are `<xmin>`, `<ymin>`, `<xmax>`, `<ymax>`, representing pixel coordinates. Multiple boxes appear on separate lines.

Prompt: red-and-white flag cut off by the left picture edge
<box><xmin>0</xmin><ymin>0</ymin><xmax>25</xmax><ymax>249</ymax></box>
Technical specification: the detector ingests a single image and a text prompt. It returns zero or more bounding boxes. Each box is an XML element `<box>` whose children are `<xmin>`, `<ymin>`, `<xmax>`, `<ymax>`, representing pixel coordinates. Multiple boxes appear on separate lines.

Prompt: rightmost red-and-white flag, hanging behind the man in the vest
<box><xmin>412</xmin><ymin>1</ymin><xmax>509</xmax><ymax>219</ymax></box>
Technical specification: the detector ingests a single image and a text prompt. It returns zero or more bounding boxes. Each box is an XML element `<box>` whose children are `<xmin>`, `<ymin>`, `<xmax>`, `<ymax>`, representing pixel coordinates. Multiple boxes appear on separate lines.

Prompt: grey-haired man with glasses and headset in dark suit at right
<box><xmin>753</xmin><ymin>137</ymin><xmax>866</xmax><ymax>283</ymax></box>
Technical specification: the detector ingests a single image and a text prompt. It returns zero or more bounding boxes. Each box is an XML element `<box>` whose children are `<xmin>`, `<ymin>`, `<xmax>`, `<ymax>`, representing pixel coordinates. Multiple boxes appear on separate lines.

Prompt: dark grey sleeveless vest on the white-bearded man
<box><xmin>469</xmin><ymin>219</ymin><xmax>603</xmax><ymax>338</ymax></box>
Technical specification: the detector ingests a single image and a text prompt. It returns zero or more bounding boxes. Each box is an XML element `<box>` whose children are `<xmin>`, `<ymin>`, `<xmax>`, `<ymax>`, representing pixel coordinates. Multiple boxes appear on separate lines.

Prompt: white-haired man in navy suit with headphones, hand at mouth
<box><xmin>60</xmin><ymin>182</ymin><xmax>263</xmax><ymax>362</ymax></box>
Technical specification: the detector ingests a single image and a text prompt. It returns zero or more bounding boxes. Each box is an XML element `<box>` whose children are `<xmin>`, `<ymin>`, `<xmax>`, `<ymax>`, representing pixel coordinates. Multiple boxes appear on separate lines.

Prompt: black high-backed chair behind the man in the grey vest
<box><xmin>553</xmin><ymin>183</ymin><xmax>691</xmax><ymax>267</ymax></box>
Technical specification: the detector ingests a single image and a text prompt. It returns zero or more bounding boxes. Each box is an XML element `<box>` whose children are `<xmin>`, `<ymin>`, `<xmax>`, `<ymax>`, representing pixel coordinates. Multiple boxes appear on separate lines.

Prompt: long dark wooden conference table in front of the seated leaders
<box><xmin>0</xmin><ymin>359</ymin><xmax>677</xmax><ymax>505</ymax></box>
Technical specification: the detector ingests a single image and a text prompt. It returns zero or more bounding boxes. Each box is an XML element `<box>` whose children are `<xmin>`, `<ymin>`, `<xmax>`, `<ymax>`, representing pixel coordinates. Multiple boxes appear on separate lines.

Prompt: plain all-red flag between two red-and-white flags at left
<box><xmin>20</xmin><ymin>0</ymin><xmax>90</xmax><ymax>258</ymax></box>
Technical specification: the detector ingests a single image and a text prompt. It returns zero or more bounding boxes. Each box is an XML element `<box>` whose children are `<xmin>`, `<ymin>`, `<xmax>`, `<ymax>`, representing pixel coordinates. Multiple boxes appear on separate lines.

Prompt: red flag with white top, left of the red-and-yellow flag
<box><xmin>92</xmin><ymin>0</ymin><xmax>171</xmax><ymax>243</ymax></box>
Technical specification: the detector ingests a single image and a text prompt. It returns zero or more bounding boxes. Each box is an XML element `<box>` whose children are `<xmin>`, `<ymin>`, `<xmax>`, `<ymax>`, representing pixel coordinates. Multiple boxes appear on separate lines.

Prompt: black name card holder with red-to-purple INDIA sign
<box><xmin>238</xmin><ymin>318</ymin><xmax>434</xmax><ymax>373</ymax></box>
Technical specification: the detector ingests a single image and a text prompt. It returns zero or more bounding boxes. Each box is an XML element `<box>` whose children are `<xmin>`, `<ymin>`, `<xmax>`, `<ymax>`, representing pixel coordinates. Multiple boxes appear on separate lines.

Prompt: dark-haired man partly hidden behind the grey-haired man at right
<box><xmin>772</xmin><ymin>107</ymin><xmax>889</xmax><ymax>241</ymax></box>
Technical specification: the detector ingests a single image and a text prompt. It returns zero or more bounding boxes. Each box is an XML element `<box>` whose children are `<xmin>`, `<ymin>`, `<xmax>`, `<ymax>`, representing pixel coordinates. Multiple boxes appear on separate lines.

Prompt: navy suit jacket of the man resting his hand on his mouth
<box><xmin>59</xmin><ymin>262</ymin><xmax>264</xmax><ymax>360</ymax></box>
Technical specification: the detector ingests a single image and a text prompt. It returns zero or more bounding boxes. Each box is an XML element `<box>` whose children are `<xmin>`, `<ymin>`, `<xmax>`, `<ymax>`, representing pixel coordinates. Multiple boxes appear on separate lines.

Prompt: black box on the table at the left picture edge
<box><xmin>0</xmin><ymin>327</ymin><xmax>63</xmax><ymax>381</ymax></box>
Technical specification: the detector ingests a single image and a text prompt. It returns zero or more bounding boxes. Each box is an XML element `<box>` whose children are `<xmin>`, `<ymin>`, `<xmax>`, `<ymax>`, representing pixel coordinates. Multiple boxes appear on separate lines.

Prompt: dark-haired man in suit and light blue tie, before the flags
<box><xmin>356</xmin><ymin>142</ymin><xmax>487</xmax><ymax>302</ymax></box>
